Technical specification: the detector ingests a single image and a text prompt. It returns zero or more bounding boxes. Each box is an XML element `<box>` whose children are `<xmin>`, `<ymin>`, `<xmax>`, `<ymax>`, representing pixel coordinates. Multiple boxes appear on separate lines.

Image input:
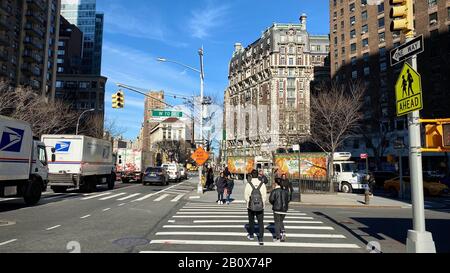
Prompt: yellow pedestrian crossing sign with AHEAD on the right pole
<box><xmin>395</xmin><ymin>62</ymin><xmax>423</xmax><ymax>116</ymax></box>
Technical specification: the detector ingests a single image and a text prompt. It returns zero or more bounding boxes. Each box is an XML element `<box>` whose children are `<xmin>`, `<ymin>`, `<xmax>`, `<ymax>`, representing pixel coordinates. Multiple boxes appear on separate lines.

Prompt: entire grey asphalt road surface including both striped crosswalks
<box><xmin>0</xmin><ymin>175</ymin><xmax>450</xmax><ymax>253</ymax></box>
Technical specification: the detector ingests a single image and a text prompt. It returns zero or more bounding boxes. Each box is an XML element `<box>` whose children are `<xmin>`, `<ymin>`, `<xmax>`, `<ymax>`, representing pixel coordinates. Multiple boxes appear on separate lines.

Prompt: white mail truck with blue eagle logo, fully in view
<box><xmin>42</xmin><ymin>135</ymin><xmax>116</xmax><ymax>193</ymax></box>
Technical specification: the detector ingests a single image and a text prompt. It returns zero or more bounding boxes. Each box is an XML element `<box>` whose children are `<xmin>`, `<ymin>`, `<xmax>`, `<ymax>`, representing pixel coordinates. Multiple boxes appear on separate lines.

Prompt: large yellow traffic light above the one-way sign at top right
<box><xmin>390</xmin><ymin>0</ymin><xmax>414</xmax><ymax>38</ymax></box>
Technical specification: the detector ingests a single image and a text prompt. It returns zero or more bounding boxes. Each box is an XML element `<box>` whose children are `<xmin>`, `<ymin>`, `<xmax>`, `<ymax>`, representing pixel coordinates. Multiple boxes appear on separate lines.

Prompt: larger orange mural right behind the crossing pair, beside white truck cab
<box><xmin>275</xmin><ymin>153</ymin><xmax>327</xmax><ymax>178</ymax></box>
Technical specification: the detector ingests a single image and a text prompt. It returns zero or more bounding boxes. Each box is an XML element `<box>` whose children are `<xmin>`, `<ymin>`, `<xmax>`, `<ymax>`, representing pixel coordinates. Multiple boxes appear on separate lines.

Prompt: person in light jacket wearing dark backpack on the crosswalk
<box><xmin>244</xmin><ymin>170</ymin><xmax>267</xmax><ymax>246</ymax></box>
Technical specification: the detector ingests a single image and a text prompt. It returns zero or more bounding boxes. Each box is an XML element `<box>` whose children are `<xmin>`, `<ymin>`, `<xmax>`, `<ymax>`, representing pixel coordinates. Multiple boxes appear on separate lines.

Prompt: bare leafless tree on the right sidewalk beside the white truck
<box><xmin>311</xmin><ymin>82</ymin><xmax>365</xmax><ymax>191</ymax></box>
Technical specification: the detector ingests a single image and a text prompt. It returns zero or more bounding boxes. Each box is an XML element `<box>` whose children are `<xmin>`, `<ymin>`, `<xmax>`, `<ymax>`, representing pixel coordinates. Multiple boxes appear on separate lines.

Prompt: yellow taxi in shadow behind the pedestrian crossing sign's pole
<box><xmin>384</xmin><ymin>176</ymin><xmax>448</xmax><ymax>197</ymax></box>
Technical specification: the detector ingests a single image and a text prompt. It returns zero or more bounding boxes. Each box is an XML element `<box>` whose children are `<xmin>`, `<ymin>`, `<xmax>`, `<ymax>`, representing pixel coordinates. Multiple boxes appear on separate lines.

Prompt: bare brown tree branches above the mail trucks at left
<box><xmin>0</xmin><ymin>83</ymin><xmax>78</xmax><ymax>137</ymax></box>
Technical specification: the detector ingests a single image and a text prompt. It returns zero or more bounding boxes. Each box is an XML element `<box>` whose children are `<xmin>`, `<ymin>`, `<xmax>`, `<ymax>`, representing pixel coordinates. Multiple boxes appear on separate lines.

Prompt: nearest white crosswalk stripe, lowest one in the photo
<box><xmin>150</xmin><ymin>240</ymin><xmax>360</xmax><ymax>248</ymax></box>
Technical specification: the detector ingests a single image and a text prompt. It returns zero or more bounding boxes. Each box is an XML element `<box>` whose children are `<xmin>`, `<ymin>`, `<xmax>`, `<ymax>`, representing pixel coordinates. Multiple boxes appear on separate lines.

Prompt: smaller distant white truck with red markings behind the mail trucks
<box><xmin>116</xmin><ymin>148</ymin><xmax>151</xmax><ymax>183</ymax></box>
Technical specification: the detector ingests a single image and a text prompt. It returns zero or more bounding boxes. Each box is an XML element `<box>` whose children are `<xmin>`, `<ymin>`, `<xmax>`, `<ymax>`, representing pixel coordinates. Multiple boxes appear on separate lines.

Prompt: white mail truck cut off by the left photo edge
<box><xmin>0</xmin><ymin>116</ymin><xmax>48</xmax><ymax>206</ymax></box>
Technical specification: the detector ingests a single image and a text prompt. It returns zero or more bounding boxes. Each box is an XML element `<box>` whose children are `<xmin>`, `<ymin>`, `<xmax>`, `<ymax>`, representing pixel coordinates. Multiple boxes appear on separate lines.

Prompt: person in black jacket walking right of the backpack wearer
<box><xmin>269</xmin><ymin>179</ymin><xmax>289</xmax><ymax>242</ymax></box>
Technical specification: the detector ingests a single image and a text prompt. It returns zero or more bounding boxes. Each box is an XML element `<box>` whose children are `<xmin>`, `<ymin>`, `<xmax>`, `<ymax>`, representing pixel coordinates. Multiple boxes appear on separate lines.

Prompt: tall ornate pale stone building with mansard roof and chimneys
<box><xmin>224</xmin><ymin>14</ymin><xmax>329</xmax><ymax>159</ymax></box>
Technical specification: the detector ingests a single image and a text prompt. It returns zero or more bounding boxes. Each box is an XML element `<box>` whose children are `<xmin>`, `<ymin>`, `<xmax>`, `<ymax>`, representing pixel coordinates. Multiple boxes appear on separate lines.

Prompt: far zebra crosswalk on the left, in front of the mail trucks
<box><xmin>0</xmin><ymin>183</ymin><xmax>195</xmax><ymax>204</ymax></box>
